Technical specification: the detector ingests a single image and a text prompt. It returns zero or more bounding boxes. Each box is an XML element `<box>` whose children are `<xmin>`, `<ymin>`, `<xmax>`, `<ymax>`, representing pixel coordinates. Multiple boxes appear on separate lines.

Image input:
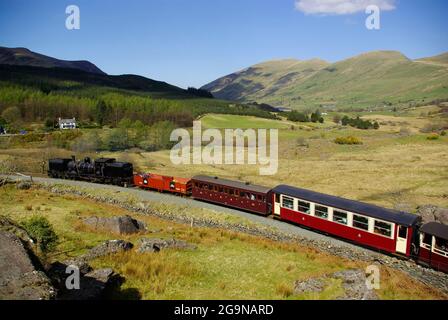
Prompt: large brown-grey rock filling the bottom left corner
<box><xmin>0</xmin><ymin>230</ymin><xmax>56</xmax><ymax>300</ymax></box>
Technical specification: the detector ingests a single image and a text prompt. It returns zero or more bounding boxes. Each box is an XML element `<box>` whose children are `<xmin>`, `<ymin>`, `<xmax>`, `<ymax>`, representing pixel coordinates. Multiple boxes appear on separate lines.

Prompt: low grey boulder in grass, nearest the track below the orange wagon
<box><xmin>83</xmin><ymin>216</ymin><xmax>146</xmax><ymax>234</ymax></box>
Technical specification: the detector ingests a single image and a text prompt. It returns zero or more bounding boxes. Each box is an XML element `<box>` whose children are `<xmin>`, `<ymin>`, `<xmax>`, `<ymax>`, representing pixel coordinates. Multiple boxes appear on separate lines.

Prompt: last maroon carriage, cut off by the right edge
<box><xmin>418</xmin><ymin>222</ymin><xmax>448</xmax><ymax>272</ymax></box>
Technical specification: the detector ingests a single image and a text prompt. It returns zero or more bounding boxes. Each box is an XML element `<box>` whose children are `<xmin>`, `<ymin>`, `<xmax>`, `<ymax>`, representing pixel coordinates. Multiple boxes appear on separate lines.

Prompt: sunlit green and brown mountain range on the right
<box><xmin>202</xmin><ymin>51</ymin><xmax>448</xmax><ymax>109</ymax></box>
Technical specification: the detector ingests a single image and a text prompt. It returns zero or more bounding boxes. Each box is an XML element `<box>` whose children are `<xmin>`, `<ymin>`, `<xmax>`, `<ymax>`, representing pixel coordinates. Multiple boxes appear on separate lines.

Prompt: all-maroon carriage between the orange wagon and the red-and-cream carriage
<box><xmin>191</xmin><ymin>175</ymin><xmax>271</xmax><ymax>215</ymax></box>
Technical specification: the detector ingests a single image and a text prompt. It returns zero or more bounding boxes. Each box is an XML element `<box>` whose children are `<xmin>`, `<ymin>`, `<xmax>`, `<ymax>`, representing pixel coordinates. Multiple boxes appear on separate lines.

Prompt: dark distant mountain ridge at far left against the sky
<box><xmin>0</xmin><ymin>47</ymin><xmax>105</xmax><ymax>74</ymax></box>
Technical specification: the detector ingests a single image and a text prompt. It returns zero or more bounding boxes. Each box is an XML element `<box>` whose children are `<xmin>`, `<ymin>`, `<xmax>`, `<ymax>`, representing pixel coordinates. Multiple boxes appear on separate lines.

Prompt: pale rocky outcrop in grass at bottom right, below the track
<box><xmin>294</xmin><ymin>269</ymin><xmax>378</xmax><ymax>300</ymax></box>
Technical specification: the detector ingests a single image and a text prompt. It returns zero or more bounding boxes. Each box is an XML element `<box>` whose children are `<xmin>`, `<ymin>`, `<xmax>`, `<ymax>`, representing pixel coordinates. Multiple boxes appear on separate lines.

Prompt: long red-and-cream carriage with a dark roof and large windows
<box><xmin>272</xmin><ymin>185</ymin><xmax>421</xmax><ymax>256</ymax></box>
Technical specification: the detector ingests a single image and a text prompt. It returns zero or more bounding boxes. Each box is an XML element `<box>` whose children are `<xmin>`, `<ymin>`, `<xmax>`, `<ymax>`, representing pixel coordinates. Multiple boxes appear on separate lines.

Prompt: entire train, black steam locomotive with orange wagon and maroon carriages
<box><xmin>48</xmin><ymin>159</ymin><xmax>448</xmax><ymax>272</ymax></box>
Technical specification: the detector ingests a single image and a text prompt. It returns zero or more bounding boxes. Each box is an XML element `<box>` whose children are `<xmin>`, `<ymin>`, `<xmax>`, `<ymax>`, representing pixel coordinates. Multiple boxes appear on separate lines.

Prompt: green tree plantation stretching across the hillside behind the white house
<box><xmin>0</xmin><ymin>83</ymin><xmax>275</xmax><ymax>132</ymax></box>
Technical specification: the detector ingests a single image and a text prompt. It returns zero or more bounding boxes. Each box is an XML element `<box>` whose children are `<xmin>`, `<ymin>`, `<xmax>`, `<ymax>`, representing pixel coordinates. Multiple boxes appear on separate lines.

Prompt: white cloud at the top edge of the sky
<box><xmin>295</xmin><ymin>0</ymin><xmax>395</xmax><ymax>15</ymax></box>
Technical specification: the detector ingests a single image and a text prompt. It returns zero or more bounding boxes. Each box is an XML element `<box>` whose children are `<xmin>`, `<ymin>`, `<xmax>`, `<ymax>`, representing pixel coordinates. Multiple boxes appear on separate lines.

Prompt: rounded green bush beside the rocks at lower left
<box><xmin>22</xmin><ymin>216</ymin><xmax>58</xmax><ymax>253</ymax></box>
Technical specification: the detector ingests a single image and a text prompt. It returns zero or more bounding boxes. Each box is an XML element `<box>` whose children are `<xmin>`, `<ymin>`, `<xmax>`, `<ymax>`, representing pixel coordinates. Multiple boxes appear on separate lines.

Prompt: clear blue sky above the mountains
<box><xmin>0</xmin><ymin>0</ymin><xmax>448</xmax><ymax>87</ymax></box>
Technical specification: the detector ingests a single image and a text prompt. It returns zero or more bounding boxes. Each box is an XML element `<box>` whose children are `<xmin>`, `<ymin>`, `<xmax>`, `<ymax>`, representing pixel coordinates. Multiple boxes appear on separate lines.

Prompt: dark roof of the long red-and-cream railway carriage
<box><xmin>272</xmin><ymin>185</ymin><xmax>421</xmax><ymax>226</ymax></box>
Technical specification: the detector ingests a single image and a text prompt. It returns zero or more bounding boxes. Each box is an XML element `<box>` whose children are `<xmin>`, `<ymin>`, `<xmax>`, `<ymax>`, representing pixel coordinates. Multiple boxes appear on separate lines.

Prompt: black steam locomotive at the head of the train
<box><xmin>48</xmin><ymin>156</ymin><xmax>134</xmax><ymax>187</ymax></box>
